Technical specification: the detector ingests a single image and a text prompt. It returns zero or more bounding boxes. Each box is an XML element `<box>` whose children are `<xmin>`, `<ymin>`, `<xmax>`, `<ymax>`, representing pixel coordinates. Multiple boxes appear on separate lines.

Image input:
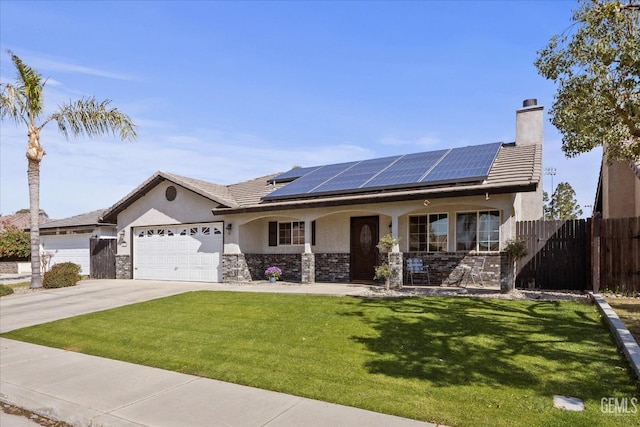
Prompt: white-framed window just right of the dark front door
<box><xmin>409</xmin><ymin>214</ymin><xmax>449</xmax><ymax>252</ymax></box>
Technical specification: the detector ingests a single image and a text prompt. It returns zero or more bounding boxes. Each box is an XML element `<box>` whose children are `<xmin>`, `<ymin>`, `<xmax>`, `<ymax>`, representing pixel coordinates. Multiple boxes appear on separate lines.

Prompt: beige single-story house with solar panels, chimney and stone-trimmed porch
<box><xmin>102</xmin><ymin>100</ymin><xmax>543</xmax><ymax>284</ymax></box>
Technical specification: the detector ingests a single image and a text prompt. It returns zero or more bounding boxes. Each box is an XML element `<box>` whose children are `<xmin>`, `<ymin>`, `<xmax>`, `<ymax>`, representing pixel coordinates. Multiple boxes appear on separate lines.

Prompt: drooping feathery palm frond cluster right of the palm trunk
<box><xmin>51</xmin><ymin>97</ymin><xmax>136</xmax><ymax>140</ymax></box>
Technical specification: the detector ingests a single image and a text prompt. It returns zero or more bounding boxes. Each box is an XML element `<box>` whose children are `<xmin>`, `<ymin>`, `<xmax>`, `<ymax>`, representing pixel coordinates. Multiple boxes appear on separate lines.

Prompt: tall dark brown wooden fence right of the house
<box><xmin>516</xmin><ymin>217</ymin><xmax>640</xmax><ymax>294</ymax></box>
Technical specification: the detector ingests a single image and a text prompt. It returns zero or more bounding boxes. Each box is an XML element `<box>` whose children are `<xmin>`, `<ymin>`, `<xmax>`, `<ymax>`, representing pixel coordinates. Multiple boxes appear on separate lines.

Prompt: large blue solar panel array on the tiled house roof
<box><xmin>265</xmin><ymin>142</ymin><xmax>502</xmax><ymax>200</ymax></box>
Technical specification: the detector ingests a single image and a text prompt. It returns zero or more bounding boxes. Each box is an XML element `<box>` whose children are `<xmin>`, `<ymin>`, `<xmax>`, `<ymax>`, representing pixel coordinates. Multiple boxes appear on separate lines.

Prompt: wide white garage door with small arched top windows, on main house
<box><xmin>133</xmin><ymin>222</ymin><xmax>223</xmax><ymax>282</ymax></box>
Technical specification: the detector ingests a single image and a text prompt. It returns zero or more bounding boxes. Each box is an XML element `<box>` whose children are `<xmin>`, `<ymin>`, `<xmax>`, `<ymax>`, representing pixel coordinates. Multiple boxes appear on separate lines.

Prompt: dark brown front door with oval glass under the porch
<box><xmin>351</xmin><ymin>216</ymin><xmax>379</xmax><ymax>281</ymax></box>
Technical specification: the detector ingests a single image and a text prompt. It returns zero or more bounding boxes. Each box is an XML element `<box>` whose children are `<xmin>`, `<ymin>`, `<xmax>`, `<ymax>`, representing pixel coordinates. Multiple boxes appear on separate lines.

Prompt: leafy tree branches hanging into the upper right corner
<box><xmin>535</xmin><ymin>0</ymin><xmax>640</xmax><ymax>162</ymax></box>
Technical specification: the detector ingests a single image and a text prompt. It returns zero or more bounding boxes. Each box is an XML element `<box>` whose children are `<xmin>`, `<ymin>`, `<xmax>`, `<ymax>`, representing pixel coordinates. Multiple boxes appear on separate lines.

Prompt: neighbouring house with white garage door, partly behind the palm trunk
<box><xmin>40</xmin><ymin>209</ymin><xmax>116</xmax><ymax>276</ymax></box>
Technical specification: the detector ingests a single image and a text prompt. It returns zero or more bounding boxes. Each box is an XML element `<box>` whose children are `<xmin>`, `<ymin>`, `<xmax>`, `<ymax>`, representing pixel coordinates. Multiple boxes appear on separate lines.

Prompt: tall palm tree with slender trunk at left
<box><xmin>0</xmin><ymin>51</ymin><xmax>136</xmax><ymax>288</ymax></box>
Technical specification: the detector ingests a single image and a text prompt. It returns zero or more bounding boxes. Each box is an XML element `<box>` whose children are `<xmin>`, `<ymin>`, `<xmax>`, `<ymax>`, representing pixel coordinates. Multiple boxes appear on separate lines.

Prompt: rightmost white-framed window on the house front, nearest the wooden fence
<box><xmin>456</xmin><ymin>211</ymin><xmax>500</xmax><ymax>252</ymax></box>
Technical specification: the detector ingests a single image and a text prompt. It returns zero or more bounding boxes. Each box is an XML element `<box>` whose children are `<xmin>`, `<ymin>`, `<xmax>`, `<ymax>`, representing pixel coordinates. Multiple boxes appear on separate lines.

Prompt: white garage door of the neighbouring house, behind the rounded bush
<box><xmin>40</xmin><ymin>233</ymin><xmax>91</xmax><ymax>276</ymax></box>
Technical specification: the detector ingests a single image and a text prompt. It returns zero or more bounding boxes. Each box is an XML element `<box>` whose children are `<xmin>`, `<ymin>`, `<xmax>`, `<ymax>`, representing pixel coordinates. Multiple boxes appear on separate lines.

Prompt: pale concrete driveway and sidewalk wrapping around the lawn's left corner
<box><xmin>0</xmin><ymin>280</ymin><xmax>440</xmax><ymax>427</ymax></box>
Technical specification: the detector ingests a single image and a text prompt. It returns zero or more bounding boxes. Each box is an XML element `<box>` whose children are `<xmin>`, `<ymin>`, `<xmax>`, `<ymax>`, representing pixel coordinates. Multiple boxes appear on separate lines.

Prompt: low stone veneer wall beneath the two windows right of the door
<box><xmin>404</xmin><ymin>252</ymin><xmax>508</xmax><ymax>287</ymax></box>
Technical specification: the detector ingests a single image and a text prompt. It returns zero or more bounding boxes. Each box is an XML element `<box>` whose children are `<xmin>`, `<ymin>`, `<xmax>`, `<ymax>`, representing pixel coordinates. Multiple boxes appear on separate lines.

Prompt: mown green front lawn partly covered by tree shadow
<box><xmin>3</xmin><ymin>291</ymin><xmax>640</xmax><ymax>426</ymax></box>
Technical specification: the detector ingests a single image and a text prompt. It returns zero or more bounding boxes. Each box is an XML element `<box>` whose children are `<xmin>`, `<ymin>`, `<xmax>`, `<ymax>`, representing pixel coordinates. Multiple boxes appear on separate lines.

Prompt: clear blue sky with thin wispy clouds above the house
<box><xmin>0</xmin><ymin>0</ymin><xmax>600</xmax><ymax>218</ymax></box>
